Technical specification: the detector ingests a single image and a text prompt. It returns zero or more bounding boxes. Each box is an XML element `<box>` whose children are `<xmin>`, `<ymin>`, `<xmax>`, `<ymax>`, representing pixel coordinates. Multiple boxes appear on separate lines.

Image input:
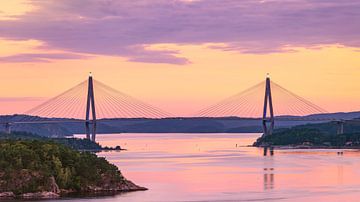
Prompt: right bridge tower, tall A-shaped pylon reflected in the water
<box><xmin>262</xmin><ymin>74</ymin><xmax>275</xmax><ymax>136</ymax></box>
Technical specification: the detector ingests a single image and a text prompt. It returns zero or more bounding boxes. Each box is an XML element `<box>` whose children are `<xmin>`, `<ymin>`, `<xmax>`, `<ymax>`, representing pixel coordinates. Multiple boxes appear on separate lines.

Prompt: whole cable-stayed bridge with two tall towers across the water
<box><xmin>0</xmin><ymin>74</ymin><xmax>354</xmax><ymax>141</ymax></box>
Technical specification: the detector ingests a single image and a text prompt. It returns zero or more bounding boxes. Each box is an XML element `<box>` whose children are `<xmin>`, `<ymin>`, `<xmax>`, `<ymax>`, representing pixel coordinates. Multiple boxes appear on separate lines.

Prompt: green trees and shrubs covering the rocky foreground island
<box><xmin>0</xmin><ymin>140</ymin><xmax>123</xmax><ymax>193</ymax></box>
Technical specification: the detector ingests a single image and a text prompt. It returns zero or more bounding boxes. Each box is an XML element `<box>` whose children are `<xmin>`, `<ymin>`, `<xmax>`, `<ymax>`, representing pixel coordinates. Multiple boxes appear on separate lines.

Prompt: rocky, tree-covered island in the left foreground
<box><xmin>0</xmin><ymin>139</ymin><xmax>147</xmax><ymax>199</ymax></box>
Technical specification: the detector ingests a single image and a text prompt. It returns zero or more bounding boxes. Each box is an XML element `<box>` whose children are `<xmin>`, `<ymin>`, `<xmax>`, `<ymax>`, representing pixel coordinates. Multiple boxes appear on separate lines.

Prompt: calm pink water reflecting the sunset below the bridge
<box><xmin>52</xmin><ymin>134</ymin><xmax>360</xmax><ymax>202</ymax></box>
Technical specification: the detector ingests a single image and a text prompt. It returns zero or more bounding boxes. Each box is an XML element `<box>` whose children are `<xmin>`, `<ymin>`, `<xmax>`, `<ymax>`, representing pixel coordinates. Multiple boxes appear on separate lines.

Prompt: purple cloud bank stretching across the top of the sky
<box><xmin>0</xmin><ymin>0</ymin><xmax>360</xmax><ymax>65</ymax></box>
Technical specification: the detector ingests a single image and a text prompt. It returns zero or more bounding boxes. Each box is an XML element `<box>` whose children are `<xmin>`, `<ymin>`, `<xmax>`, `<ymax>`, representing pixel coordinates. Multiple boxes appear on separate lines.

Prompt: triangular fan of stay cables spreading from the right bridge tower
<box><xmin>195</xmin><ymin>77</ymin><xmax>327</xmax><ymax>118</ymax></box>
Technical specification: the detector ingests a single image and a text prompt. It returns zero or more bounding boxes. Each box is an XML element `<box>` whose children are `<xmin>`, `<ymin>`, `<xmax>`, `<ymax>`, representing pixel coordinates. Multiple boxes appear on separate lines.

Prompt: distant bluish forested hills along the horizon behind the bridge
<box><xmin>0</xmin><ymin>112</ymin><xmax>360</xmax><ymax>137</ymax></box>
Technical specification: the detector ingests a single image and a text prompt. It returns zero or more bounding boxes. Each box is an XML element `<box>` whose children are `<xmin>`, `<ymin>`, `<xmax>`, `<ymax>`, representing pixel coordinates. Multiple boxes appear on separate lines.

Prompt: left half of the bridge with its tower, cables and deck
<box><xmin>4</xmin><ymin>74</ymin><xmax>173</xmax><ymax>141</ymax></box>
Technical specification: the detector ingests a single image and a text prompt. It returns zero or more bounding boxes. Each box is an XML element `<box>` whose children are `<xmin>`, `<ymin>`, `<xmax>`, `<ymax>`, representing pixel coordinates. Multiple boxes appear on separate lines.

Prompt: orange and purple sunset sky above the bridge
<box><xmin>0</xmin><ymin>0</ymin><xmax>360</xmax><ymax>116</ymax></box>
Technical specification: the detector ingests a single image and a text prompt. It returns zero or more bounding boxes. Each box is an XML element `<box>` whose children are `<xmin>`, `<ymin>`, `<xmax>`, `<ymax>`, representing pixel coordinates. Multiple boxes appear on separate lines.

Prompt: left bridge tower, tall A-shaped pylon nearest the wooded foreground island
<box><xmin>85</xmin><ymin>72</ymin><xmax>96</xmax><ymax>141</ymax></box>
